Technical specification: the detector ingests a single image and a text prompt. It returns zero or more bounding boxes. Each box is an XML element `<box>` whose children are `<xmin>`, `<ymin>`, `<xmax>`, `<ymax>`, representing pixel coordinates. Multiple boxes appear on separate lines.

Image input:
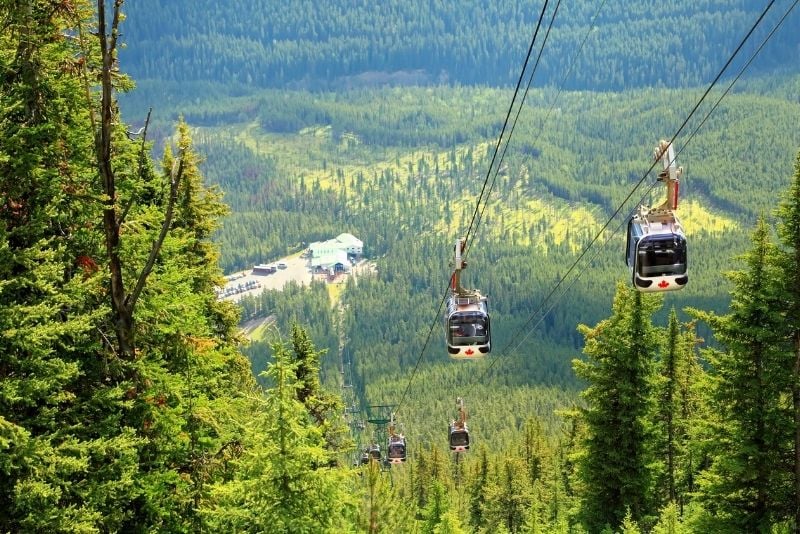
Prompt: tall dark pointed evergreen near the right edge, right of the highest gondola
<box><xmin>693</xmin><ymin>219</ymin><xmax>793</xmax><ymax>532</ymax></box>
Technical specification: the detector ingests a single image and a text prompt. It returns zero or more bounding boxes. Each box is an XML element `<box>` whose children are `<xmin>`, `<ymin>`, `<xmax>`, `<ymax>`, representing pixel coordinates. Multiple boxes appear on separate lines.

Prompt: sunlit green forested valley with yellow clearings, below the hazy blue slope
<box><xmin>185</xmin><ymin>80</ymin><xmax>800</xmax><ymax>446</ymax></box>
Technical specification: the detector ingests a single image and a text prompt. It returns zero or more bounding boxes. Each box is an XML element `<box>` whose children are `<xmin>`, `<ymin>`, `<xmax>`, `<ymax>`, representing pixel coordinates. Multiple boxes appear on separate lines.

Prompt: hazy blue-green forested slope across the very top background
<box><xmin>120</xmin><ymin>0</ymin><xmax>800</xmax><ymax>90</ymax></box>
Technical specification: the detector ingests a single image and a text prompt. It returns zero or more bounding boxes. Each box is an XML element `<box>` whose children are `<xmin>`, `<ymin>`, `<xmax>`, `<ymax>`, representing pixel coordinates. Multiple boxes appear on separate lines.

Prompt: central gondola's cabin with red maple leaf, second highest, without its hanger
<box><xmin>445</xmin><ymin>292</ymin><xmax>492</xmax><ymax>359</ymax></box>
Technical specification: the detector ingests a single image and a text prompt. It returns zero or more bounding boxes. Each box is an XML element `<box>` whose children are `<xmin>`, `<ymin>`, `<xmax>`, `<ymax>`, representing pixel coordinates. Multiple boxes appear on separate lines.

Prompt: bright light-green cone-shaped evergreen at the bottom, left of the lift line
<box><xmin>204</xmin><ymin>343</ymin><xmax>354</xmax><ymax>533</ymax></box>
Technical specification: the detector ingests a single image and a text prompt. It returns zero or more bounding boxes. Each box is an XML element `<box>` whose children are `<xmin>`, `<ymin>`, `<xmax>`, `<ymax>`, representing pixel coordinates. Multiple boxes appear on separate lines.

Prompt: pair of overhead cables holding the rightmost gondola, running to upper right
<box><xmin>466</xmin><ymin>0</ymin><xmax>800</xmax><ymax>390</ymax></box>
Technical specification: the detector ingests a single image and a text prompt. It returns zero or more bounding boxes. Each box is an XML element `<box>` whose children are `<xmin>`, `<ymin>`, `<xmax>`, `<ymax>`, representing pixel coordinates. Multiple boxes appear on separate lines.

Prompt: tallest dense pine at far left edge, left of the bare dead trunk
<box><xmin>0</xmin><ymin>1</ymin><xmax>141</xmax><ymax>532</ymax></box>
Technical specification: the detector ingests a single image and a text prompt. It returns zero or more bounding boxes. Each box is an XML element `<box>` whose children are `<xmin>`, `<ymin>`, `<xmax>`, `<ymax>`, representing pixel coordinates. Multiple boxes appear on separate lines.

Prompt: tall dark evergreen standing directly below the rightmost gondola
<box><xmin>573</xmin><ymin>284</ymin><xmax>661</xmax><ymax>531</ymax></box>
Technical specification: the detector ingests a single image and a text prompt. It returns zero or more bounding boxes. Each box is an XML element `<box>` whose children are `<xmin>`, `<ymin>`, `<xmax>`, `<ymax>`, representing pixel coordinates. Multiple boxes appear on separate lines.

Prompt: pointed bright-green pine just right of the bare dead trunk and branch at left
<box><xmin>120</xmin><ymin>122</ymin><xmax>255</xmax><ymax>531</ymax></box>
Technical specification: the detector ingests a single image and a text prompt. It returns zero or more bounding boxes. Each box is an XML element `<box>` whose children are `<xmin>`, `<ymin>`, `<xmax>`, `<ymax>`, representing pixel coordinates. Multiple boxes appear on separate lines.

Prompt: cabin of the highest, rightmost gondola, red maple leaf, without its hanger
<box><xmin>626</xmin><ymin>213</ymin><xmax>689</xmax><ymax>291</ymax></box>
